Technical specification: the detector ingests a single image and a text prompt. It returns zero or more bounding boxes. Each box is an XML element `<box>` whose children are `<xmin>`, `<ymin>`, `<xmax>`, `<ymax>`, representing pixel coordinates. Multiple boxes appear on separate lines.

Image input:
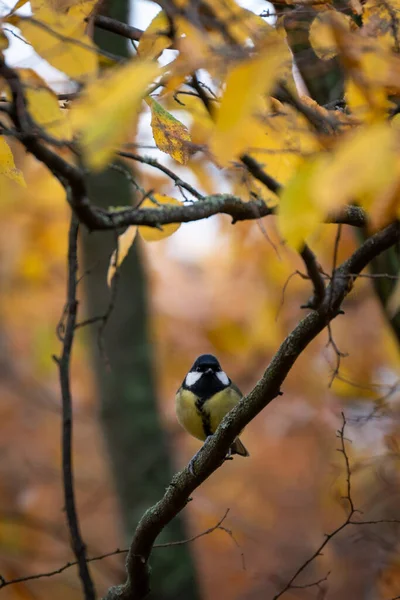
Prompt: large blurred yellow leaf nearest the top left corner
<box><xmin>19</xmin><ymin>6</ymin><xmax>98</xmax><ymax>80</ymax></box>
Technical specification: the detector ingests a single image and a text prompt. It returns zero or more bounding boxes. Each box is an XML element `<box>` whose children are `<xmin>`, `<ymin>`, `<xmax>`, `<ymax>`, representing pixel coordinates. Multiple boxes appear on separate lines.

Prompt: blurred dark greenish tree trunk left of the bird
<box><xmin>82</xmin><ymin>0</ymin><xmax>199</xmax><ymax>600</ymax></box>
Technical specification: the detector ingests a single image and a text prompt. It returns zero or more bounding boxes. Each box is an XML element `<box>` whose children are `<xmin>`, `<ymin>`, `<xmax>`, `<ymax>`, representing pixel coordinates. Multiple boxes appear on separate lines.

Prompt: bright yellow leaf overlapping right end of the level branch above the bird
<box><xmin>278</xmin><ymin>160</ymin><xmax>324</xmax><ymax>250</ymax></box>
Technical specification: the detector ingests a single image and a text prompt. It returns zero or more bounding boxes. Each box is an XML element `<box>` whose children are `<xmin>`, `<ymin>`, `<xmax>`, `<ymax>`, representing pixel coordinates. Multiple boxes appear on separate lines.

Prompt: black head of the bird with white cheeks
<box><xmin>182</xmin><ymin>354</ymin><xmax>231</xmax><ymax>400</ymax></box>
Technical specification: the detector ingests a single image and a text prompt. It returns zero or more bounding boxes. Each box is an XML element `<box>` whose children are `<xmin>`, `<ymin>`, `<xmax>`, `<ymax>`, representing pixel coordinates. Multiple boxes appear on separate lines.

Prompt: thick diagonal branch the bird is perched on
<box><xmin>105</xmin><ymin>223</ymin><xmax>400</xmax><ymax>600</ymax></box>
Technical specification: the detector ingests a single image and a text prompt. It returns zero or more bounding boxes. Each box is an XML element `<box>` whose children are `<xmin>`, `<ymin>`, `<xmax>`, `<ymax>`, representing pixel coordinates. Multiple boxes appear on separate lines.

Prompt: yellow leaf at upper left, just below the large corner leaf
<box><xmin>17</xmin><ymin>69</ymin><xmax>72</xmax><ymax>140</ymax></box>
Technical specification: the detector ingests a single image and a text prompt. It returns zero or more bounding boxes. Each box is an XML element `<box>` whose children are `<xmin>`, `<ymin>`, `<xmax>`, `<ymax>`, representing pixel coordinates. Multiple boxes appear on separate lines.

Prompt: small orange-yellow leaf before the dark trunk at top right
<box><xmin>310</xmin><ymin>9</ymin><xmax>351</xmax><ymax>60</ymax></box>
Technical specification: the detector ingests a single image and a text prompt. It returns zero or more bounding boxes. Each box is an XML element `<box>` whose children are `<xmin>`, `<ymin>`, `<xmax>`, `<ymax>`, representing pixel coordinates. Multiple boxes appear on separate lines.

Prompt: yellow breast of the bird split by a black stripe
<box><xmin>175</xmin><ymin>387</ymin><xmax>241</xmax><ymax>440</ymax></box>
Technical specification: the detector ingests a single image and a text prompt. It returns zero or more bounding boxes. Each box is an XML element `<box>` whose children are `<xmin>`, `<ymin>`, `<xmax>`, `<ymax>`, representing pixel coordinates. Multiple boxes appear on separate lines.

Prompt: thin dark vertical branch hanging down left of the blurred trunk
<box><xmin>56</xmin><ymin>215</ymin><xmax>96</xmax><ymax>600</ymax></box>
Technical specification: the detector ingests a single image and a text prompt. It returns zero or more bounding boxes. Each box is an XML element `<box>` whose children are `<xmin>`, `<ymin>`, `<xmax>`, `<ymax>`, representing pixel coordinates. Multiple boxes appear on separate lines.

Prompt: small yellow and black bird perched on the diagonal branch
<box><xmin>175</xmin><ymin>354</ymin><xmax>249</xmax><ymax>464</ymax></box>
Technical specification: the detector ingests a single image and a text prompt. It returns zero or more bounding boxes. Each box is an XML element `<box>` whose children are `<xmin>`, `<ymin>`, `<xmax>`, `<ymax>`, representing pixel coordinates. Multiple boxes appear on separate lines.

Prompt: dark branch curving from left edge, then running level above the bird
<box><xmin>0</xmin><ymin>58</ymin><xmax>367</xmax><ymax>230</ymax></box>
